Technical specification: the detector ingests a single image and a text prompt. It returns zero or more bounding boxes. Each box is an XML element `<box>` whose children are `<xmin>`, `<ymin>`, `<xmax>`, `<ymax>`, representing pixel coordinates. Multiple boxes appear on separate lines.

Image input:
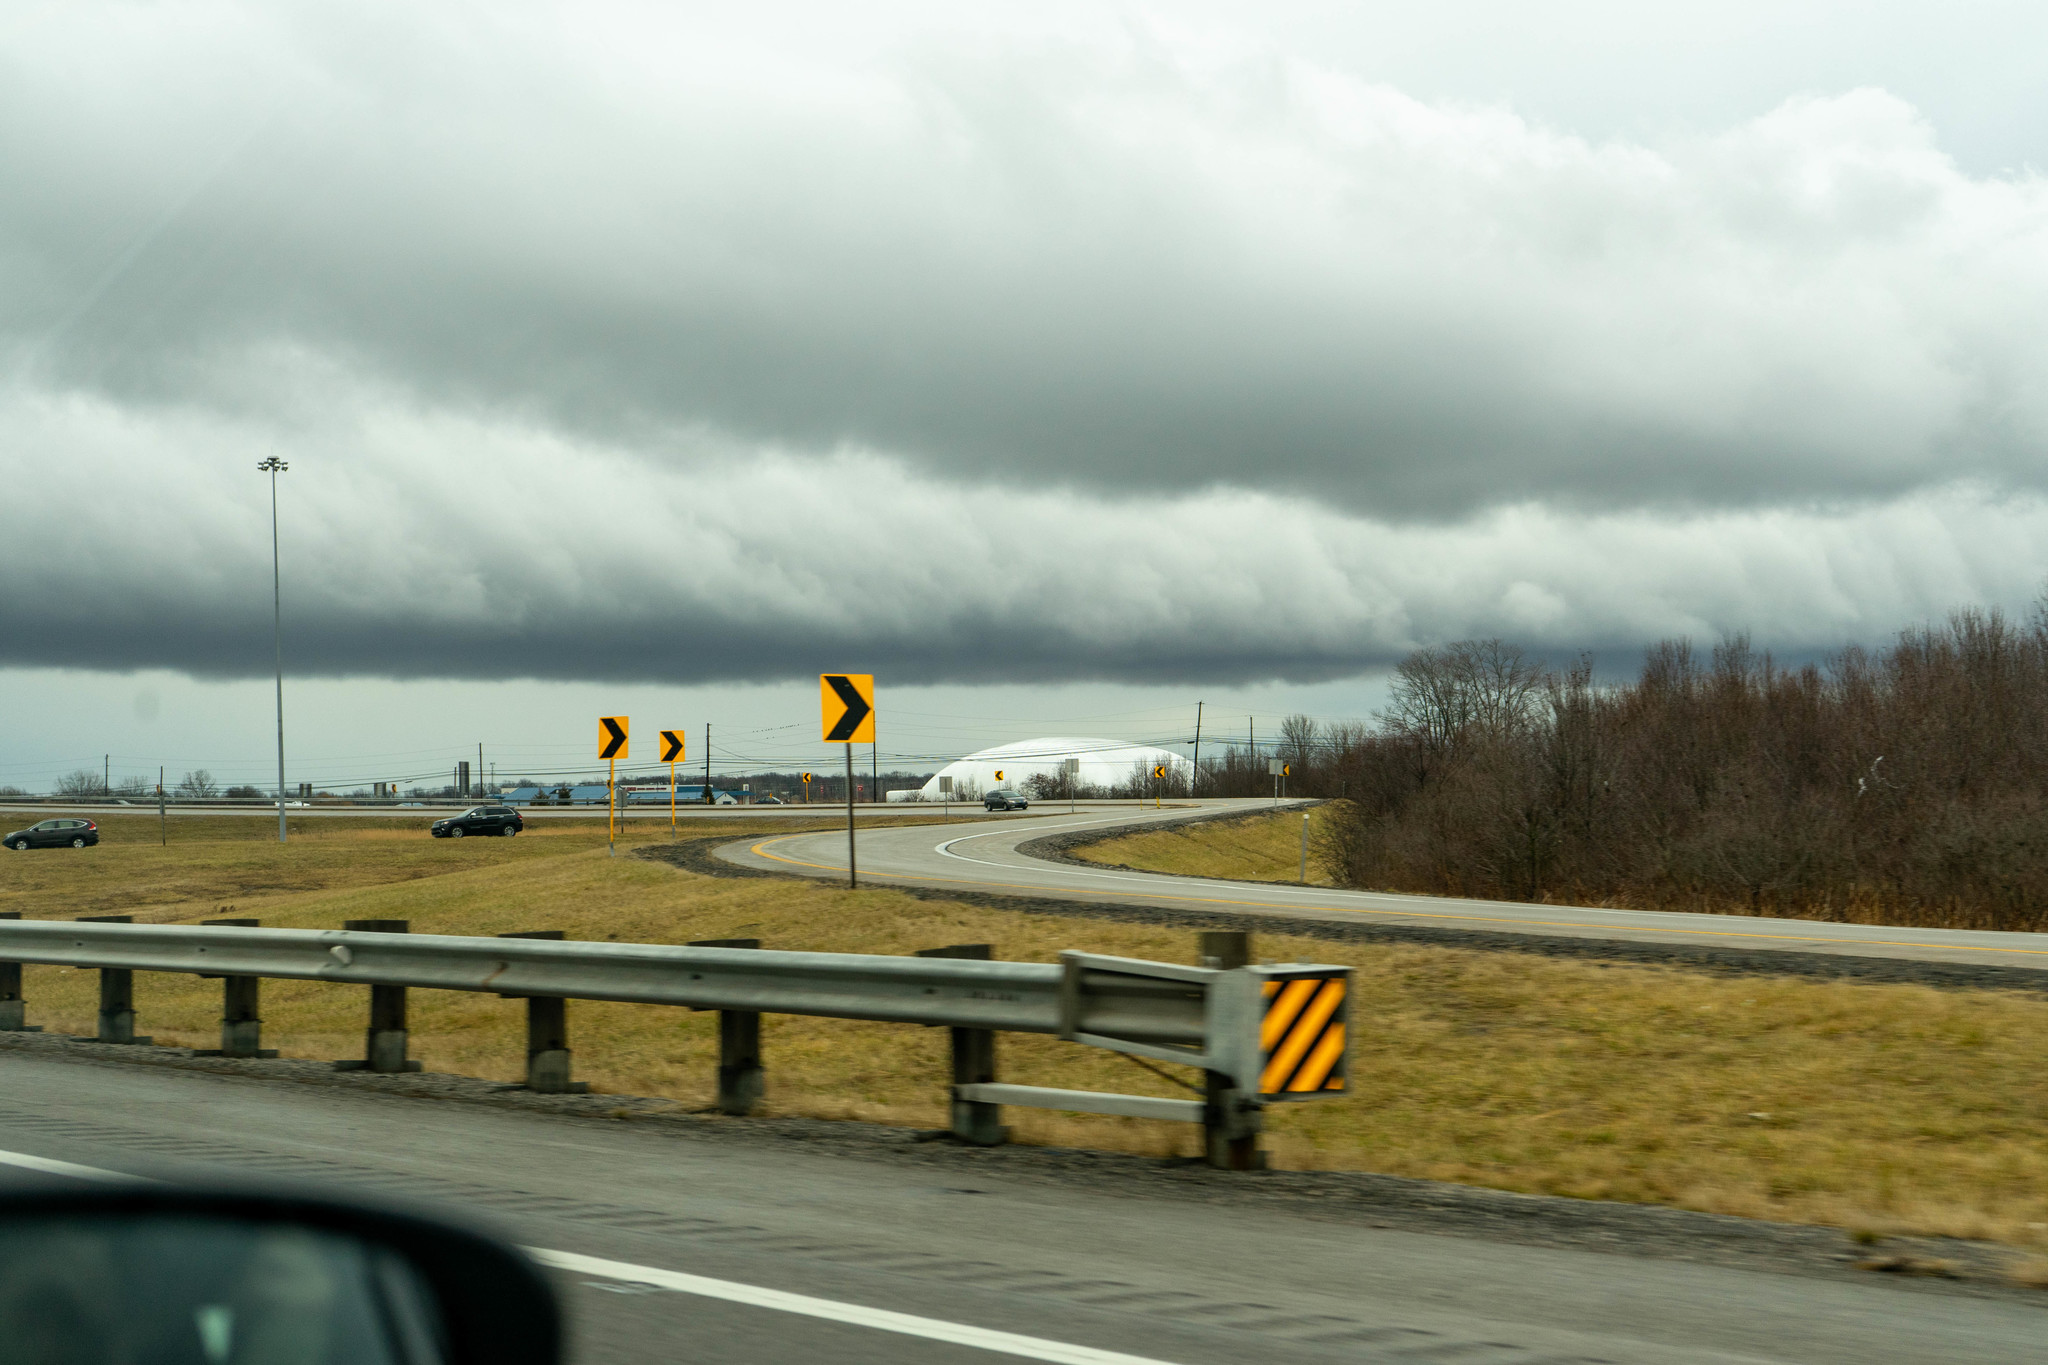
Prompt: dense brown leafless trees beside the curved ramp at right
<box><xmin>1245</xmin><ymin>608</ymin><xmax>2048</xmax><ymax>929</ymax></box>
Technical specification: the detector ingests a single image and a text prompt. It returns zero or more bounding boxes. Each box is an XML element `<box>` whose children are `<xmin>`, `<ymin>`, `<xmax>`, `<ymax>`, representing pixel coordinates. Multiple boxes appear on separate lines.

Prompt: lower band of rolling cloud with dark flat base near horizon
<box><xmin>0</xmin><ymin>366</ymin><xmax>2048</xmax><ymax>684</ymax></box>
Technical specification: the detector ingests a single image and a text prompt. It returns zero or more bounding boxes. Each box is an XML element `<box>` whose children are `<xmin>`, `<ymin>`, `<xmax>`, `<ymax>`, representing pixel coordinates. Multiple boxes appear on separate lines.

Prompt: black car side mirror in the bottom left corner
<box><xmin>0</xmin><ymin>1185</ymin><xmax>561</xmax><ymax>1365</ymax></box>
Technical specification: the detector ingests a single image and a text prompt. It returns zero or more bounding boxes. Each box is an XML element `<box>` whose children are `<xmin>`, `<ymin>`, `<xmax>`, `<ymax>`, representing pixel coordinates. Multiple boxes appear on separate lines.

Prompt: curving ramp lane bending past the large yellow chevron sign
<box><xmin>719</xmin><ymin>802</ymin><xmax>2048</xmax><ymax>970</ymax></box>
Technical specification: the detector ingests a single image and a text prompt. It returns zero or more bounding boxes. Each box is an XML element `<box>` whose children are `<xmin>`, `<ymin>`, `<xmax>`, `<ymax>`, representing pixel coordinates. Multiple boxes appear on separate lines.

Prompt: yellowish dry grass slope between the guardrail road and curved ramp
<box><xmin>0</xmin><ymin>817</ymin><xmax>2048</xmax><ymax>1268</ymax></box>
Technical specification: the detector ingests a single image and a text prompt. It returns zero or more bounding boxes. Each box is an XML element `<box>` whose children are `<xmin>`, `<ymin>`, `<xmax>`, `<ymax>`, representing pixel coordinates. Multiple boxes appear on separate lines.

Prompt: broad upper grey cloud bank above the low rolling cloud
<box><xmin>0</xmin><ymin>6</ymin><xmax>2048</xmax><ymax>518</ymax></box>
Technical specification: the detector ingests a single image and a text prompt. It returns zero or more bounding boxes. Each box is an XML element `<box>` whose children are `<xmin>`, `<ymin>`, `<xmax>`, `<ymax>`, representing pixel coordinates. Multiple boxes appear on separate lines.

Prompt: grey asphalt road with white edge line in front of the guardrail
<box><xmin>0</xmin><ymin>1050</ymin><xmax>2048</xmax><ymax>1365</ymax></box>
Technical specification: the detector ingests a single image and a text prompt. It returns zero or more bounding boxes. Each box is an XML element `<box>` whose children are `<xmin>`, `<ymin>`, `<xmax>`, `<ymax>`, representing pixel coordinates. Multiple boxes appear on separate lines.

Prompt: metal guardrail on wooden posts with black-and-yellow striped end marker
<box><xmin>0</xmin><ymin>915</ymin><xmax>1350</xmax><ymax>1169</ymax></box>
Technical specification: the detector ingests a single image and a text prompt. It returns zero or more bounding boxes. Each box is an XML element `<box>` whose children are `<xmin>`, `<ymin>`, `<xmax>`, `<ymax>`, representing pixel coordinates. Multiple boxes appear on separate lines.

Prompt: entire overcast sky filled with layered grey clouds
<box><xmin>0</xmin><ymin>0</ymin><xmax>2048</xmax><ymax>786</ymax></box>
